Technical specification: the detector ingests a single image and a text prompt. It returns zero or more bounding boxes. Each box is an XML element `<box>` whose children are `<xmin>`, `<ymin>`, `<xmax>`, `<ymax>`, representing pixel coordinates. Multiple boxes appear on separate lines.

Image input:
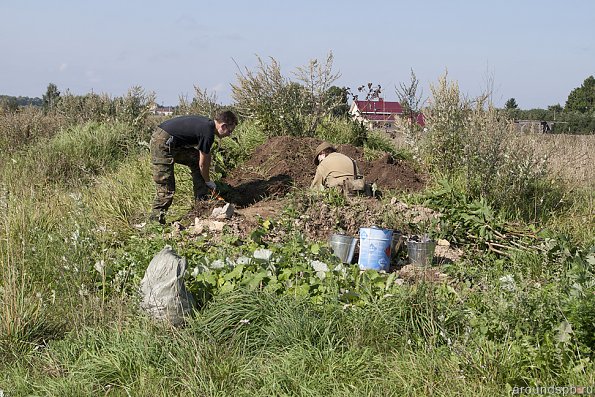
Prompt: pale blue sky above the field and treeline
<box><xmin>0</xmin><ymin>0</ymin><xmax>595</xmax><ymax>109</ymax></box>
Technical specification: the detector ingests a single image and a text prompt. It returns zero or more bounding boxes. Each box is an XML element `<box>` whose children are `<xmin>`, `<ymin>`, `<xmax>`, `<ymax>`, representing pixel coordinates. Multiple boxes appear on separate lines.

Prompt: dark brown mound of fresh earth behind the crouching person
<box><xmin>222</xmin><ymin>136</ymin><xmax>424</xmax><ymax>207</ymax></box>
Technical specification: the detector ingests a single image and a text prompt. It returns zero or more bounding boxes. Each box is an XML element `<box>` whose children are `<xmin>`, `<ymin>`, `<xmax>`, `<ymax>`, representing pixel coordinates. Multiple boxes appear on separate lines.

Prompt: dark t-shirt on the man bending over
<box><xmin>159</xmin><ymin>116</ymin><xmax>215</xmax><ymax>154</ymax></box>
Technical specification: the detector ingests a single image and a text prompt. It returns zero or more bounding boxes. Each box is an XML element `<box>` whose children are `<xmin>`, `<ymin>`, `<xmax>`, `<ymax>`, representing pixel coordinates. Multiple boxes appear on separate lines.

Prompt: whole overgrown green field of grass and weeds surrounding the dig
<box><xmin>0</xmin><ymin>78</ymin><xmax>595</xmax><ymax>397</ymax></box>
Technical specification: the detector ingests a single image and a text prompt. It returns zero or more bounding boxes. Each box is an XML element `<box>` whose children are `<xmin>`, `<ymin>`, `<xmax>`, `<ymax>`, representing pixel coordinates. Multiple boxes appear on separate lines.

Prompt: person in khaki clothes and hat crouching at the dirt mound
<box><xmin>310</xmin><ymin>142</ymin><xmax>369</xmax><ymax>196</ymax></box>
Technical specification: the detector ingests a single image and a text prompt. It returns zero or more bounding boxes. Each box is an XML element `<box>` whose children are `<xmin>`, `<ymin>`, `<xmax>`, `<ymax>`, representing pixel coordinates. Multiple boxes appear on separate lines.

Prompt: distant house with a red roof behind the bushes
<box><xmin>349</xmin><ymin>98</ymin><xmax>425</xmax><ymax>131</ymax></box>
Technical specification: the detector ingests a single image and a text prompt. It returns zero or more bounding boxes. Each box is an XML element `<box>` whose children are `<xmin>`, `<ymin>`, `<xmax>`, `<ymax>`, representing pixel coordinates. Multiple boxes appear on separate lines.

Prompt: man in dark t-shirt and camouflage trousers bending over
<box><xmin>150</xmin><ymin>110</ymin><xmax>238</xmax><ymax>224</ymax></box>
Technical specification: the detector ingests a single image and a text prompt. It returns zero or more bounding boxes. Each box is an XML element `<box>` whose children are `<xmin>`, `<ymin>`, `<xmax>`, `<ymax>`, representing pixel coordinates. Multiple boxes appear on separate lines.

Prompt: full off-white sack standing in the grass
<box><xmin>140</xmin><ymin>245</ymin><xmax>195</xmax><ymax>326</ymax></box>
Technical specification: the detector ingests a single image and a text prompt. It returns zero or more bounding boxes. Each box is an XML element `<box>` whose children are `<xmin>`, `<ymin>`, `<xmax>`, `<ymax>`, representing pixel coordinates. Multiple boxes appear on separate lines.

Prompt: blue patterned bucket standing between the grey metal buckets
<box><xmin>357</xmin><ymin>227</ymin><xmax>393</xmax><ymax>271</ymax></box>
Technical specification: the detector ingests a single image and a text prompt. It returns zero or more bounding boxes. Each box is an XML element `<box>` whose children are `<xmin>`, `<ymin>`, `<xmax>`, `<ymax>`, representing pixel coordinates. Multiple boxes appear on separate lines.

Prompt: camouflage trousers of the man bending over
<box><xmin>150</xmin><ymin>127</ymin><xmax>208</xmax><ymax>213</ymax></box>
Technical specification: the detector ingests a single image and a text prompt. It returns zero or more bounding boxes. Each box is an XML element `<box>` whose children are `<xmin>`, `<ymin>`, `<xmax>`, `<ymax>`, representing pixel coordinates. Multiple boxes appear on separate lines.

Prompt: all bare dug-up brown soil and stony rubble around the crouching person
<box><xmin>184</xmin><ymin>136</ymin><xmax>468</xmax><ymax>272</ymax></box>
